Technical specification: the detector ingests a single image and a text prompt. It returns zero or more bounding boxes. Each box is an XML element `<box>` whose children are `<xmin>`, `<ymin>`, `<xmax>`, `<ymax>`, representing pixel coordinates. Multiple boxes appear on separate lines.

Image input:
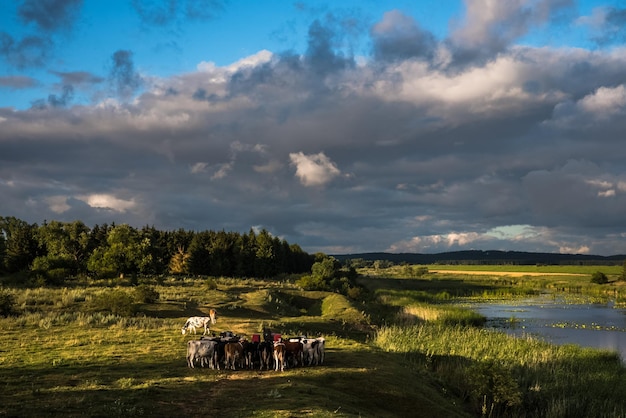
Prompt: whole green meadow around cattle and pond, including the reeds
<box><xmin>0</xmin><ymin>266</ymin><xmax>626</xmax><ymax>417</ymax></box>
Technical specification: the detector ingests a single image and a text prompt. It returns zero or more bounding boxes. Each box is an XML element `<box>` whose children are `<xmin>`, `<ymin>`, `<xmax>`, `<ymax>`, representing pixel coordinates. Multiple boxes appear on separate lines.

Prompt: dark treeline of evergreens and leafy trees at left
<box><xmin>0</xmin><ymin>217</ymin><xmax>315</xmax><ymax>284</ymax></box>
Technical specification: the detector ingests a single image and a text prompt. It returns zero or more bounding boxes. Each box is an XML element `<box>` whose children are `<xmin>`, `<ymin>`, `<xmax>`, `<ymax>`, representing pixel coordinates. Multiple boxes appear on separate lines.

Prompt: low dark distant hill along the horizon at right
<box><xmin>333</xmin><ymin>250</ymin><xmax>626</xmax><ymax>265</ymax></box>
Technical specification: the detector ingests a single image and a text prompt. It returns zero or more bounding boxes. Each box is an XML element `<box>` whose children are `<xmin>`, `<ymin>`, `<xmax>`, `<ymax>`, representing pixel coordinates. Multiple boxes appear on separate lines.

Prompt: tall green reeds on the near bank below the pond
<box><xmin>374</xmin><ymin>318</ymin><xmax>626</xmax><ymax>418</ymax></box>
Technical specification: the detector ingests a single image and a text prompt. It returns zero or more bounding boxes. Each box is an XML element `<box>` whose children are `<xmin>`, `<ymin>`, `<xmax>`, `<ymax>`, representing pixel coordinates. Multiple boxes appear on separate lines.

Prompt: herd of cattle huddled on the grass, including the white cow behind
<box><xmin>182</xmin><ymin>316</ymin><xmax>325</xmax><ymax>371</ymax></box>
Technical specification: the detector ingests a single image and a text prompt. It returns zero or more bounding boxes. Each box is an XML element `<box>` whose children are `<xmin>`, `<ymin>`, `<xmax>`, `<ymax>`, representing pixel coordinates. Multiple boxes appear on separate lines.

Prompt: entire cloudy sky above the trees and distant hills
<box><xmin>0</xmin><ymin>0</ymin><xmax>626</xmax><ymax>255</ymax></box>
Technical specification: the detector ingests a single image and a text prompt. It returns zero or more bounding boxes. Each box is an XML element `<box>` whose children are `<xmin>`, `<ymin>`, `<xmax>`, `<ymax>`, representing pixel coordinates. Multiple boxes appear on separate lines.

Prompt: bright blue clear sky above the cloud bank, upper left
<box><xmin>0</xmin><ymin>0</ymin><xmax>462</xmax><ymax>109</ymax></box>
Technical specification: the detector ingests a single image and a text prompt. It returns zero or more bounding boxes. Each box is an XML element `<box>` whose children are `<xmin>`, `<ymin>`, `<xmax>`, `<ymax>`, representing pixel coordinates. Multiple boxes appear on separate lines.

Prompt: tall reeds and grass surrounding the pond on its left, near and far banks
<box><xmin>363</xmin><ymin>266</ymin><xmax>626</xmax><ymax>418</ymax></box>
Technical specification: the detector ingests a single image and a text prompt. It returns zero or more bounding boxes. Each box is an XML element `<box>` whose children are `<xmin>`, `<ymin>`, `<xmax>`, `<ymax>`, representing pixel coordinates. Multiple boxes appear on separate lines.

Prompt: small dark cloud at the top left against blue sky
<box><xmin>17</xmin><ymin>0</ymin><xmax>83</xmax><ymax>32</ymax></box>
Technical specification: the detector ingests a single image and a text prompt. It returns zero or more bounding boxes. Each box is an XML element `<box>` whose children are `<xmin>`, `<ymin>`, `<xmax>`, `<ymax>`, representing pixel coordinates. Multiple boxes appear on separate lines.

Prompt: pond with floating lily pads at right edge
<box><xmin>470</xmin><ymin>295</ymin><xmax>626</xmax><ymax>362</ymax></box>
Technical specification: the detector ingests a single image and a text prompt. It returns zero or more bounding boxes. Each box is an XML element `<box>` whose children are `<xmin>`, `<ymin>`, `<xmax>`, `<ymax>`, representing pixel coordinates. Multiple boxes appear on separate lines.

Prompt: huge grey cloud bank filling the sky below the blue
<box><xmin>0</xmin><ymin>1</ymin><xmax>626</xmax><ymax>254</ymax></box>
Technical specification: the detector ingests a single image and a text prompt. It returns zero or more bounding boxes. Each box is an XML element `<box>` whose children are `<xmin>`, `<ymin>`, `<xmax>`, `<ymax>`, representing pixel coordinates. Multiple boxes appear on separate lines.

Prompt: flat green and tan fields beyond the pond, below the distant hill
<box><xmin>359</xmin><ymin>264</ymin><xmax>626</xmax><ymax>306</ymax></box>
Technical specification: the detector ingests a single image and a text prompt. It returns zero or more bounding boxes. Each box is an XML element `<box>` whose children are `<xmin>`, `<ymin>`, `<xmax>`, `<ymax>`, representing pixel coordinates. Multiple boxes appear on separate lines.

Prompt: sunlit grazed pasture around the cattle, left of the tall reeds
<box><xmin>0</xmin><ymin>279</ymin><xmax>466</xmax><ymax>417</ymax></box>
